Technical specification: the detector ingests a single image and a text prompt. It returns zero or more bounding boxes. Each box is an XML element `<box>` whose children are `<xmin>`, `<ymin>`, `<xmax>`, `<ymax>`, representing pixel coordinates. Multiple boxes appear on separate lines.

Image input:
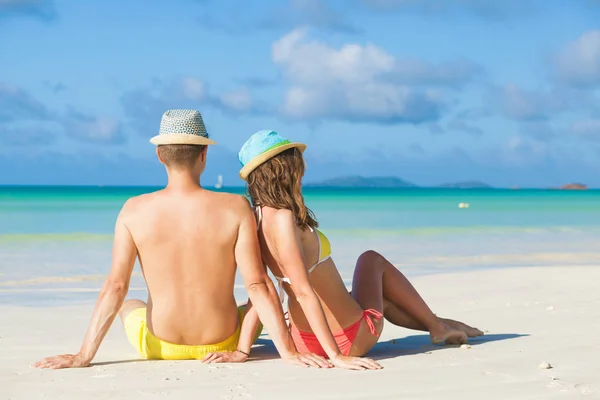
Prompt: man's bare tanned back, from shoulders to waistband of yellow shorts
<box><xmin>121</xmin><ymin>187</ymin><xmax>249</xmax><ymax>345</ymax></box>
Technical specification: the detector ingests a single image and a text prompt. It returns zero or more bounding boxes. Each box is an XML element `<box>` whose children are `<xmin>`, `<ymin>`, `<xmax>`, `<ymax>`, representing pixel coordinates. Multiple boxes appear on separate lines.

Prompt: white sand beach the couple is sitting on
<box><xmin>0</xmin><ymin>266</ymin><xmax>600</xmax><ymax>400</ymax></box>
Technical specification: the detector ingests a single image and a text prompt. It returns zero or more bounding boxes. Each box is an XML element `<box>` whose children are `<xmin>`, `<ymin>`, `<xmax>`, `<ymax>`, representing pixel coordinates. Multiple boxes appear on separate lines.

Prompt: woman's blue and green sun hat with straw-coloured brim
<box><xmin>238</xmin><ymin>130</ymin><xmax>306</xmax><ymax>180</ymax></box>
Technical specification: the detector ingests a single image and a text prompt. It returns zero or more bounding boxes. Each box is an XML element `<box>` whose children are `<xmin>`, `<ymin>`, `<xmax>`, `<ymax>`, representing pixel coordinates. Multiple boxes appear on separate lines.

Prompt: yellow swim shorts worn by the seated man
<box><xmin>124</xmin><ymin>306</ymin><xmax>262</xmax><ymax>360</ymax></box>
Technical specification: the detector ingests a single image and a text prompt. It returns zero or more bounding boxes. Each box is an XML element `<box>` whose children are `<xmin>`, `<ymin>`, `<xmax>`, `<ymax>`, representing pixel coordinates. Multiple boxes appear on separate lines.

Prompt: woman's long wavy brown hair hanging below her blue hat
<box><xmin>247</xmin><ymin>147</ymin><xmax>319</xmax><ymax>229</ymax></box>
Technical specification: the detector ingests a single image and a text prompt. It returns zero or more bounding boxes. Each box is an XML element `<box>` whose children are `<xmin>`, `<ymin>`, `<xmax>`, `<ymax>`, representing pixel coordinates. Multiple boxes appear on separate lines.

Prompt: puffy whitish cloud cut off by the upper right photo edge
<box><xmin>555</xmin><ymin>30</ymin><xmax>600</xmax><ymax>86</ymax></box>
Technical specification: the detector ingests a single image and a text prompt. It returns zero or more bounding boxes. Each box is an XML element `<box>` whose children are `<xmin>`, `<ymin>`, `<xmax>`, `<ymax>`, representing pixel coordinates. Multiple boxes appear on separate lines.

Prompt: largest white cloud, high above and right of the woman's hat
<box><xmin>272</xmin><ymin>29</ymin><xmax>479</xmax><ymax>123</ymax></box>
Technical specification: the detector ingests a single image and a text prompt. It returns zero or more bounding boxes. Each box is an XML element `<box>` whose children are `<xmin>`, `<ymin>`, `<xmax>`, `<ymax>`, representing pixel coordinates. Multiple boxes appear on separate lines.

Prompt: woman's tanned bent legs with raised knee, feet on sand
<box><xmin>352</xmin><ymin>251</ymin><xmax>474</xmax><ymax>344</ymax></box>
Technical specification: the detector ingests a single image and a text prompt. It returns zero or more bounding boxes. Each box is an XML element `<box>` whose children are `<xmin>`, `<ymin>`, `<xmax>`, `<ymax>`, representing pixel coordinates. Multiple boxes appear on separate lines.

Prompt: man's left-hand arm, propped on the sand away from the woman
<box><xmin>33</xmin><ymin>203</ymin><xmax>137</xmax><ymax>369</ymax></box>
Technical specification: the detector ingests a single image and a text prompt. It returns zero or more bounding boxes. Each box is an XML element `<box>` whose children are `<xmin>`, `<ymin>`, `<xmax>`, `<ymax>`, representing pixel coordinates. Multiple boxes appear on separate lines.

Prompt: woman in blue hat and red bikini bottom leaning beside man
<box><xmin>206</xmin><ymin>131</ymin><xmax>483</xmax><ymax>369</ymax></box>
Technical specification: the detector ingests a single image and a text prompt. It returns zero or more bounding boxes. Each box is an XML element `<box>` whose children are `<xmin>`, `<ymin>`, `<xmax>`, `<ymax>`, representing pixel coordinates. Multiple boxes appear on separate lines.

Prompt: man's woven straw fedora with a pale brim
<box><xmin>150</xmin><ymin>110</ymin><xmax>217</xmax><ymax>146</ymax></box>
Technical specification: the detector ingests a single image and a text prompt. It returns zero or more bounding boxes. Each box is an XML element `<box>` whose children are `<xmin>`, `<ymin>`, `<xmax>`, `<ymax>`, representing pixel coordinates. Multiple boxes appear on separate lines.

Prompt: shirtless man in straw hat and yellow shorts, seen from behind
<box><xmin>34</xmin><ymin>110</ymin><xmax>329</xmax><ymax>368</ymax></box>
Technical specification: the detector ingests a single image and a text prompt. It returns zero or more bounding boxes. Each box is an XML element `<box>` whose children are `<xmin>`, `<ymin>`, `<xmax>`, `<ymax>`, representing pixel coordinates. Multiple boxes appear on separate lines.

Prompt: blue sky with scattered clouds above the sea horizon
<box><xmin>0</xmin><ymin>0</ymin><xmax>600</xmax><ymax>187</ymax></box>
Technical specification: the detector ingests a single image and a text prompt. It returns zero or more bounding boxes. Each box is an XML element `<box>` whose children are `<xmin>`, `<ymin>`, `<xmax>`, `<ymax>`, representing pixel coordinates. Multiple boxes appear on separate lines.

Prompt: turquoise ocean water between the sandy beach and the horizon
<box><xmin>0</xmin><ymin>187</ymin><xmax>600</xmax><ymax>305</ymax></box>
